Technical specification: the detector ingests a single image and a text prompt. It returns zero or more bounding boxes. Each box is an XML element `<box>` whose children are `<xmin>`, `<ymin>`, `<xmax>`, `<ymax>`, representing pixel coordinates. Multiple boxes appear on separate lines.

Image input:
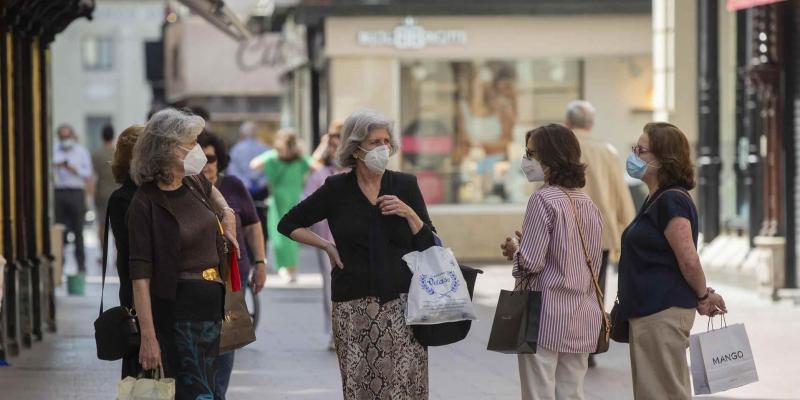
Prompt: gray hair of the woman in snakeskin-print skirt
<box><xmin>336</xmin><ymin>109</ymin><xmax>398</xmax><ymax>167</ymax></box>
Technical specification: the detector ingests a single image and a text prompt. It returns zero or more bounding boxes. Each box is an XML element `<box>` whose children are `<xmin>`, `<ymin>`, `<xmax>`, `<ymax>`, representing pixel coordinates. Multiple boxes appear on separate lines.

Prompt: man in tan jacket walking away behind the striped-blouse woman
<box><xmin>564</xmin><ymin>100</ymin><xmax>636</xmax><ymax>367</ymax></box>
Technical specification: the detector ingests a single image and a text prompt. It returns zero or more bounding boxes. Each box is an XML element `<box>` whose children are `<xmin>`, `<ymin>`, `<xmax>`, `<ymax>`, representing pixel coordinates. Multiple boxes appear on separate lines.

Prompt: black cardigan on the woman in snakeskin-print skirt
<box><xmin>278</xmin><ymin>171</ymin><xmax>435</xmax><ymax>303</ymax></box>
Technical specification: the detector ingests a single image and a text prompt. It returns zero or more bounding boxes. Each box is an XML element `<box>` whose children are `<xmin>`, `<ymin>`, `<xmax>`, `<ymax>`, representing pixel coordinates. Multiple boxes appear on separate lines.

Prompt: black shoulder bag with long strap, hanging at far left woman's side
<box><xmin>94</xmin><ymin>210</ymin><xmax>141</xmax><ymax>361</ymax></box>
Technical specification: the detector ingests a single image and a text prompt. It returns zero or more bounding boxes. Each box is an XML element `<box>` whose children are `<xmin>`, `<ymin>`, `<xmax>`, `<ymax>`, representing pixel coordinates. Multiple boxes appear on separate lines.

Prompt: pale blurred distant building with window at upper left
<box><xmin>52</xmin><ymin>0</ymin><xmax>164</xmax><ymax>150</ymax></box>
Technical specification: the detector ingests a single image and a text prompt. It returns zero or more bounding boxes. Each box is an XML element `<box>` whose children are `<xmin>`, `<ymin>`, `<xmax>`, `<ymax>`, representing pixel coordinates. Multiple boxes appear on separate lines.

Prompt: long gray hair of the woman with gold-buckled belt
<box><xmin>131</xmin><ymin>108</ymin><xmax>206</xmax><ymax>185</ymax></box>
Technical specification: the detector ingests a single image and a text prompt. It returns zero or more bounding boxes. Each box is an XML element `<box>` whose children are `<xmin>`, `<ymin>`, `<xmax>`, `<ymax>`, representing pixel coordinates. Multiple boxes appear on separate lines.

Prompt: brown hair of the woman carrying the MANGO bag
<box><xmin>644</xmin><ymin>122</ymin><xmax>696</xmax><ymax>190</ymax></box>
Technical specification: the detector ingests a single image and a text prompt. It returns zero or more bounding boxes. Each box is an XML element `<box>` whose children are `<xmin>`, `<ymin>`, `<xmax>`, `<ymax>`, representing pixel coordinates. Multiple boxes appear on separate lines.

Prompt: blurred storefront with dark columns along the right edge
<box><xmin>697</xmin><ymin>0</ymin><xmax>800</xmax><ymax>297</ymax></box>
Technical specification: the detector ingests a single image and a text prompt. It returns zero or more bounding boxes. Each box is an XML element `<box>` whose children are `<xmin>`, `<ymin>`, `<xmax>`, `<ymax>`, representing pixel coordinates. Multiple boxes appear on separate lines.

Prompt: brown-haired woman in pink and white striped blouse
<box><xmin>501</xmin><ymin>124</ymin><xmax>603</xmax><ymax>400</ymax></box>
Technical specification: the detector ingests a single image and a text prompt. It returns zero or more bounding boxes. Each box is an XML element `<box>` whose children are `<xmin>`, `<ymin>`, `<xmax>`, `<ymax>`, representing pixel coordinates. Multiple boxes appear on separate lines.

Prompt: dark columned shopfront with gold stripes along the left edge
<box><xmin>0</xmin><ymin>0</ymin><xmax>94</xmax><ymax>361</ymax></box>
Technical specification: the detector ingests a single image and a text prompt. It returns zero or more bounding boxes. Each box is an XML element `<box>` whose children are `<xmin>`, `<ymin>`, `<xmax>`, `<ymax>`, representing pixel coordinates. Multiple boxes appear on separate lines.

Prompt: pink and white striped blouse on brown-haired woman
<box><xmin>513</xmin><ymin>186</ymin><xmax>603</xmax><ymax>353</ymax></box>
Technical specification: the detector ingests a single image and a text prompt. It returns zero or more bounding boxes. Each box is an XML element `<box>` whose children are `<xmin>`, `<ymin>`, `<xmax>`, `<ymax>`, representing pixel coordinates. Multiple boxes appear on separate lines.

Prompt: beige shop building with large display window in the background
<box><xmin>284</xmin><ymin>1</ymin><xmax>653</xmax><ymax>261</ymax></box>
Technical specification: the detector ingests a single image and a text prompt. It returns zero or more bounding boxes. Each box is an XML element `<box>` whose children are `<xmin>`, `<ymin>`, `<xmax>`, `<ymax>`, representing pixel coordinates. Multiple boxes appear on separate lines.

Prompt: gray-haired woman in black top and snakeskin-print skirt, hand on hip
<box><xmin>278</xmin><ymin>110</ymin><xmax>434</xmax><ymax>399</ymax></box>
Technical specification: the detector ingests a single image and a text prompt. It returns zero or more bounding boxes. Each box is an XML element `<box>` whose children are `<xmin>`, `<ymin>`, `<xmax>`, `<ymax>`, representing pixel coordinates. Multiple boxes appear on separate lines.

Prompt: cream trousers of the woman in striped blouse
<box><xmin>517</xmin><ymin>347</ymin><xmax>589</xmax><ymax>400</ymax></box>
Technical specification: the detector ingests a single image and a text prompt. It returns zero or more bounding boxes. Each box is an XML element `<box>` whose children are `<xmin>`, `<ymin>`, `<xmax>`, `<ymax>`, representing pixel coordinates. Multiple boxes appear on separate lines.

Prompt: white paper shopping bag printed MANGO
<box><xmin>689</xmin><ymin>318</ymin><xmax>758</xmax><ymax>395</ymax></box>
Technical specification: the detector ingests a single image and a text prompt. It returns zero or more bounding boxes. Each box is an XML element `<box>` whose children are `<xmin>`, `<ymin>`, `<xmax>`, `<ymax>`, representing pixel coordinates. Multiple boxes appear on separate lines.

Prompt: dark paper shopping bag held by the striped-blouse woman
<box><xmin>486</xmin><ymin>278</ymin><xmax>542</xmax><ymax>354</ymax></box>
